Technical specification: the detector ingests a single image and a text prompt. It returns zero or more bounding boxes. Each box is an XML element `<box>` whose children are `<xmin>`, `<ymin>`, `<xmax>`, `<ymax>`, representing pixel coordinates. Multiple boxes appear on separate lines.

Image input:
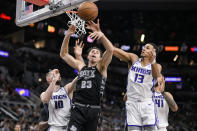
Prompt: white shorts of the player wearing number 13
<box><xmin>126</xmin><ymin>99</ymin><xmax>157</xmax><ymax>127</ymax></box>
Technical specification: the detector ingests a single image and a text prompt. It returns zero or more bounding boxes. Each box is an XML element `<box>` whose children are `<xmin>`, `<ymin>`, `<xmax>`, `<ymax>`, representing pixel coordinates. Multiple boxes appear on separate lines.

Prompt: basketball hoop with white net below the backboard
<box><xmin>66</xmin><ymin>10</ymin><xmax>86</xmax><ymax>36</ymax></box>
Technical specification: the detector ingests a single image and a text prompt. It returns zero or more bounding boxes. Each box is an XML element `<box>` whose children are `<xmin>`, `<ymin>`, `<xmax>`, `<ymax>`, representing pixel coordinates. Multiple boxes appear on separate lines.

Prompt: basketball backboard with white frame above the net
<box><xmin>16</xmin><ymin>0</ymin><xmax>97</xmax><ymax>27</ymax></box>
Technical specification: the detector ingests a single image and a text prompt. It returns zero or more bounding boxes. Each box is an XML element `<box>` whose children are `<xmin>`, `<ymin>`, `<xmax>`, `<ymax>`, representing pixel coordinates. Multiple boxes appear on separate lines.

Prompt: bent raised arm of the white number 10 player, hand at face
<box><xmin>40</xmin><ymin>72</ymin><xmax>58</xmax><ymax>103</ymax></box>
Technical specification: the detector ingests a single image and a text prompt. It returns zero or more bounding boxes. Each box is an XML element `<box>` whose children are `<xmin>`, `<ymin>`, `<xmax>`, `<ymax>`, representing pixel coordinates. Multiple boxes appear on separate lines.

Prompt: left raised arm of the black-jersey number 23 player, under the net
<box><xmin>60</xmin><ymin>25</ymin><xmax>84</xmax><ymax>71</ymax></box>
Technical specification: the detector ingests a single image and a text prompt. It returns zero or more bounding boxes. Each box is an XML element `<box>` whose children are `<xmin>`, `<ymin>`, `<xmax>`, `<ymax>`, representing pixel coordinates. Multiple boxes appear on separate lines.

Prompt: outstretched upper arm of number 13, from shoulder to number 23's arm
<box><xmin>114</xmin><ymin>47</ymin><xmax>138</xmax><ymax>65</ymax></box>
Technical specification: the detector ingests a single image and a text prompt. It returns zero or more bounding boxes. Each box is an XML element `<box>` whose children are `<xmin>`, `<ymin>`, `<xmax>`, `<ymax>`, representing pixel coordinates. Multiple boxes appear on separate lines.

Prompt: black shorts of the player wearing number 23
<box><xmin>68</xmin><ymin>105</ymin><xmax>100</xmax><ymax>131</ymax></box>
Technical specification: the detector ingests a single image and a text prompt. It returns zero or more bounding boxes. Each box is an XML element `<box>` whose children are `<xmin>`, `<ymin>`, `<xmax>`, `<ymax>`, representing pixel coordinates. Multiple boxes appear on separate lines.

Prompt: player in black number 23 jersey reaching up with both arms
<box><xmin>60</xmin><ymin>21</ymin><xmax>113</xmax><ymax>131</ymax></box>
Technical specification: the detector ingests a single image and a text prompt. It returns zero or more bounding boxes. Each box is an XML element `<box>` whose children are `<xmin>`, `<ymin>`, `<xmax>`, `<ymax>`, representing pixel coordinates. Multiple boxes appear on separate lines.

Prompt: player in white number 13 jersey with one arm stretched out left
<box><xmin>114</xmin><ymin>43</ymin><xmax>161</xmax><ymax>131</ymax></box>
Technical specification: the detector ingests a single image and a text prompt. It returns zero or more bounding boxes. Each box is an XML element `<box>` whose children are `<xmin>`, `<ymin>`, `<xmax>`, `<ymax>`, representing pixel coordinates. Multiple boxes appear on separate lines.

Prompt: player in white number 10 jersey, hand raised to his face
<box><xmin>40</xmin><ymin>69</ymin><xmax>77</xmax><ymax>131</ymax></box>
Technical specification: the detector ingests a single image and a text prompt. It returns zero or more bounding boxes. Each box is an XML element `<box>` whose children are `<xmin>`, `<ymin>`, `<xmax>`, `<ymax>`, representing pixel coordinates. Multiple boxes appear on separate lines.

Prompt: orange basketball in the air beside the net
<box><xmin>78</xmin><ymin>2</ymin><xmax>98</xmax><ymax>21</ymax></box>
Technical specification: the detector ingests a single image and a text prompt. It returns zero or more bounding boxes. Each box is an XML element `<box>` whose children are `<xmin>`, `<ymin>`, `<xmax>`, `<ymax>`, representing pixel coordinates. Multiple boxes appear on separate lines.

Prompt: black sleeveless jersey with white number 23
<box><xmin>73</xmin><ymin>66</ymin><xmax>106</xmax><ymax>105</ymax></box>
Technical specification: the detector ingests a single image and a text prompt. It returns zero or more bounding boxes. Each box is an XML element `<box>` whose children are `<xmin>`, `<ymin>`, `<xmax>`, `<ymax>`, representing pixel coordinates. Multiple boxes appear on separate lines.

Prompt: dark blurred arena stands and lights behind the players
<box><xmin>0</xmin><ymin>0</ymin><xmax>197</xmax><ymax>131</ymax></box>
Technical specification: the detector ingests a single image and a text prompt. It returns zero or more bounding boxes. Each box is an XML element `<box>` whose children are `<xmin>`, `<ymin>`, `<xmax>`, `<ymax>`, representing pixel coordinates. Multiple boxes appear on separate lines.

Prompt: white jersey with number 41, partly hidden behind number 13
<box><xmin>154</xmin><ymin>92</ymin><xmax>169</xmax><ymax>128</ymax></box>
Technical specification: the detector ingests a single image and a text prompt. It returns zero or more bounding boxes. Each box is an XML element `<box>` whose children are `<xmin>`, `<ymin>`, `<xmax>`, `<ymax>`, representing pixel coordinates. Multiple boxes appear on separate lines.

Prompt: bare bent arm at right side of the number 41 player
<box><xmin>162</xmin><ymin>92</ymin><xmax>178</xmax><ymax>112</ymax></box>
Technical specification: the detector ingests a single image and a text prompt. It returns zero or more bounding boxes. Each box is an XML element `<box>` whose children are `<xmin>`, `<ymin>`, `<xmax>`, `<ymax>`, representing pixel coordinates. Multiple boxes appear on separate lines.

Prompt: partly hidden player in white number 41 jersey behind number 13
<box><xmin>154</xmin><ymin>77</ymin><xmax>178</xmax><ymax>131</ymax></box>
